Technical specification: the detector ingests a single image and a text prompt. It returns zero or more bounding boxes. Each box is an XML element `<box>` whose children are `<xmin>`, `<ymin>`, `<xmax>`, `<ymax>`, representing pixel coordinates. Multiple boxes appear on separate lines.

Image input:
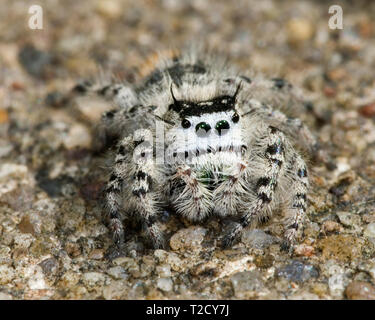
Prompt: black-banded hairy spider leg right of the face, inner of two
<box><xmin>222</xmin><ymin>127</ymin><xmax>285</xmax><ymax>247</ymax></box>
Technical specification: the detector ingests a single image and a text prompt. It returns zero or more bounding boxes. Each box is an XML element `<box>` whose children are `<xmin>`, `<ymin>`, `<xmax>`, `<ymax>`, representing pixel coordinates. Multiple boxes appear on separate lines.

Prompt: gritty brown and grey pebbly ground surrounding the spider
<box><xmin>0</xmin><ymin>0</ymin><xmax>375</xmax><ymax>299</ymax></box>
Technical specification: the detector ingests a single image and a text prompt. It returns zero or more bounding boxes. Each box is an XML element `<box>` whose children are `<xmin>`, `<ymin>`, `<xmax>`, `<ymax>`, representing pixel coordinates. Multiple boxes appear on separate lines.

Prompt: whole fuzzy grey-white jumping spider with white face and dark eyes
<box><xmin>74</xmin><ymin>53</ymin><xmax>317</xmax><ymax>254</ymax></box>
